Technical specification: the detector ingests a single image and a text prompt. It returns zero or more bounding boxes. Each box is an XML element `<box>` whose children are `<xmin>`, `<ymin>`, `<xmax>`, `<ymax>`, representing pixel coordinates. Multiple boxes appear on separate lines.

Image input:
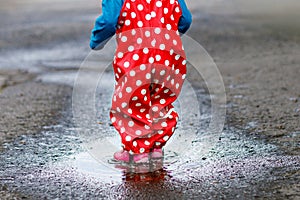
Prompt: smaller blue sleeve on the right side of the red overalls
<box><xmin>178</xmin><ymin>0</ymin><xmax>192</xmax><ymax>33</ymax></box>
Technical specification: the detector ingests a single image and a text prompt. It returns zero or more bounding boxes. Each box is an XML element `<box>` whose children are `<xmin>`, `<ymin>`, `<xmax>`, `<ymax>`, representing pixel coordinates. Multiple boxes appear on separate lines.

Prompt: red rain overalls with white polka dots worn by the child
<box><xmin>110</xmin><ymin>0</ymin><xmax>186</xmax><ymax>154</ymax></box>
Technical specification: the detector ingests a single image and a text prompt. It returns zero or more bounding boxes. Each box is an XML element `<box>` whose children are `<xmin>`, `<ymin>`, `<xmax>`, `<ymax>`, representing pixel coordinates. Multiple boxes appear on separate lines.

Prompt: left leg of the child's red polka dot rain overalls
<box><xmin>110</xmin><ymin>66</ymin><xmax>158</xmax><ymax>154</ymax></box>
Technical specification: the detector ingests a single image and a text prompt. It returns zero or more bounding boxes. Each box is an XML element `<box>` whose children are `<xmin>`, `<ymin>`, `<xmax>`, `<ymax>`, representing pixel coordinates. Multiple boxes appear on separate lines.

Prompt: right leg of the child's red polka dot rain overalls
<box><xmin>144</xmin><ymin>57</ymin><xmax>186</xmax><ymax>148</ymax></box>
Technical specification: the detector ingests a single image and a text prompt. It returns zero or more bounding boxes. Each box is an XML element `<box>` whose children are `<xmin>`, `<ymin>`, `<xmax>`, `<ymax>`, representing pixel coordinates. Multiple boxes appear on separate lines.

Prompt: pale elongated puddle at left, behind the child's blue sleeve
<box><xmin>0</xmin><ymin>40</ymin><xmax>90</xmax><ymax>73</ymax></box>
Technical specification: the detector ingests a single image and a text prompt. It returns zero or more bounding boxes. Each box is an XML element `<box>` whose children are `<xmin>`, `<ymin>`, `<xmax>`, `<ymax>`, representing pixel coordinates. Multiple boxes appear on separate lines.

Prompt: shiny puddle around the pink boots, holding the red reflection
<box><xmin>0</xmin><ymin>119</ymin><xmax>300</xmax><ymax>199</ymax></box>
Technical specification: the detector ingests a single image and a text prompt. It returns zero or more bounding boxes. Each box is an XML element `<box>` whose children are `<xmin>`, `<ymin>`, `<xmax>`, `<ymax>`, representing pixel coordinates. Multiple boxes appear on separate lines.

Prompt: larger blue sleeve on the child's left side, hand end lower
<box><xmin>90</xmin><ymin>0</ymin><xmax>124</xmax><ymax>50</ymax></box>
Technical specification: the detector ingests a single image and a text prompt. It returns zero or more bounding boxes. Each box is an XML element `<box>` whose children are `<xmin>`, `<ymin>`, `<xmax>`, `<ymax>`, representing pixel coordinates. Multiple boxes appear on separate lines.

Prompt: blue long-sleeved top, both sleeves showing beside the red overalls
<box><xmin>90</xmin><ymin>0</ymin><xmax>192</xmax><ymax>50</ymax></box>
